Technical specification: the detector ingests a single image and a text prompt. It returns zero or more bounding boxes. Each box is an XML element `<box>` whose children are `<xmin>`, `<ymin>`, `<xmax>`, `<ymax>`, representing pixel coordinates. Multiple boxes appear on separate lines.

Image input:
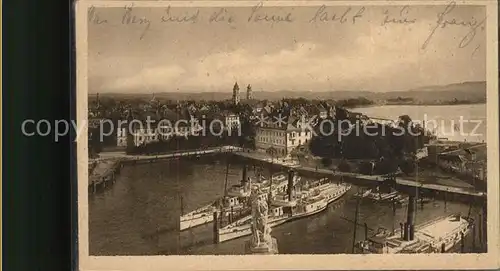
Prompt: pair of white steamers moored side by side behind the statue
<box><xmin>180</xmin><ymin>172</ymin><xmax>351</xmax><ymax>242</ymax></box>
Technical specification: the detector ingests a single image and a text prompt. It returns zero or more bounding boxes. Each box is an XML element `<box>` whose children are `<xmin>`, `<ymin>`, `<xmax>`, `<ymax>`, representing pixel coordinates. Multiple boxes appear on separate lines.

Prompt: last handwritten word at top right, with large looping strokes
<box><xmin>422</xmin><ymin>1</ymin><xmax>486</xmax><ymax>49</ymax></box>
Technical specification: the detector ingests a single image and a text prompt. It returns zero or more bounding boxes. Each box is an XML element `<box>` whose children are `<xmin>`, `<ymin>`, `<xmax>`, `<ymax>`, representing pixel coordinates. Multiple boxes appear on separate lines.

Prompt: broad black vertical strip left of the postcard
<box><xmin>2</xmin><ymin>0</ymin><xmax>71</xmax><ymax>270</ymax></box>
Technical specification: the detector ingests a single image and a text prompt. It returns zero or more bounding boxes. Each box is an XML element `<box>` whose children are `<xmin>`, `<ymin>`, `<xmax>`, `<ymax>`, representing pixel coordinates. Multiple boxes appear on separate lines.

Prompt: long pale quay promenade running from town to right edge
<box><xmin>235</xmin><ymin>152</ymin><xmax>486</xmax><ymax>198</ymax></box>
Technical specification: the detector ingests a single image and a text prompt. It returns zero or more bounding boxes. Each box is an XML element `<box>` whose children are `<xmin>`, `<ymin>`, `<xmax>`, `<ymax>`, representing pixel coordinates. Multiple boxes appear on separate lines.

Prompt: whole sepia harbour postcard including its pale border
<box><xmin>75</xmin><ymin>0</ymin><xmax>499</xmax><ymax>270</ymax></box>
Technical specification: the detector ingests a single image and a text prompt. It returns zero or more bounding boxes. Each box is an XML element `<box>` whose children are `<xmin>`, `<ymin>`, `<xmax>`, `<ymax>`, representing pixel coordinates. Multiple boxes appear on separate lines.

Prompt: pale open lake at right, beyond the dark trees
<box><xmin>353</xmin><ymin>104</ymin><xmax>487</xmax><ymax>142</ymax></box>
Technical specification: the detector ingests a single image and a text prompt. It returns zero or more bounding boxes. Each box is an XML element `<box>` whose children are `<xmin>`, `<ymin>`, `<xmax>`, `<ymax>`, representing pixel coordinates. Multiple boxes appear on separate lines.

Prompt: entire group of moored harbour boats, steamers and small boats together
<box><xmin>180</xmin><ymin>168</ymin><xmax>473</xmax><ymax>254</ymax></box>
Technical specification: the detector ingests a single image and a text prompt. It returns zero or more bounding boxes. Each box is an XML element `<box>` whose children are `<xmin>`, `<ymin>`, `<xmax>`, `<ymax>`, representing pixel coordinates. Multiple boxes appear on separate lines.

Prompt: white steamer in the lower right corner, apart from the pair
<box><xmin>355</xmin><ymin>214</ymin><xmax>473</xmax><ymax>254</ymax></box>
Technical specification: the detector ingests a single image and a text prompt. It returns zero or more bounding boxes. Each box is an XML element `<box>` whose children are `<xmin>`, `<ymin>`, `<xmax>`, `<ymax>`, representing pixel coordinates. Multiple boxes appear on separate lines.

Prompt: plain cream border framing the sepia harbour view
<box><xmin>75</xmin><ymin>0</ymin><xmax>500</xmax><ymax>270</ymax></box>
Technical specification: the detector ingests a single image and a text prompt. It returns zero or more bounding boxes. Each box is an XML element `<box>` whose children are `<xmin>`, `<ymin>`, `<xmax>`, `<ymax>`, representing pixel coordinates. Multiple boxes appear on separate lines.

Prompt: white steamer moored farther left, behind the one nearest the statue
<box><xmin>179</xmin><ymin>173</ymin><xmax>300</xmax><ymax>231</ymax></box>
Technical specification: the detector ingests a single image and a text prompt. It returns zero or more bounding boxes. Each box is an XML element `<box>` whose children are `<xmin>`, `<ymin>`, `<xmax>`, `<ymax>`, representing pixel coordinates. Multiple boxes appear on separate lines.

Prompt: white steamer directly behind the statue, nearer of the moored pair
<box><xmin>218</xmin><ymin>178</ymin><xmax>351</xmax><ymax>242</ymax></box>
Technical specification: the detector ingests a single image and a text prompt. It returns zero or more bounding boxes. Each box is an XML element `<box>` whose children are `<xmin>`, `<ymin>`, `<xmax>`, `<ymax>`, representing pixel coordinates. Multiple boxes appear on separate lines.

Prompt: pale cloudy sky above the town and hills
<box><xmin>88</xmin><ymin>2</ymin><xmax>486</xmax><ymax>93</ymax></box>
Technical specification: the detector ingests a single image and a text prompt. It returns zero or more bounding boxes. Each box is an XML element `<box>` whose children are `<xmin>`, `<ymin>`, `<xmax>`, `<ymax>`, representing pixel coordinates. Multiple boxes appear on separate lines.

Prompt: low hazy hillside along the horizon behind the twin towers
<box><xmin>94</xmin><ymin>81</ymin><xmax>486</xmax><ymax>103</ymax></box>
